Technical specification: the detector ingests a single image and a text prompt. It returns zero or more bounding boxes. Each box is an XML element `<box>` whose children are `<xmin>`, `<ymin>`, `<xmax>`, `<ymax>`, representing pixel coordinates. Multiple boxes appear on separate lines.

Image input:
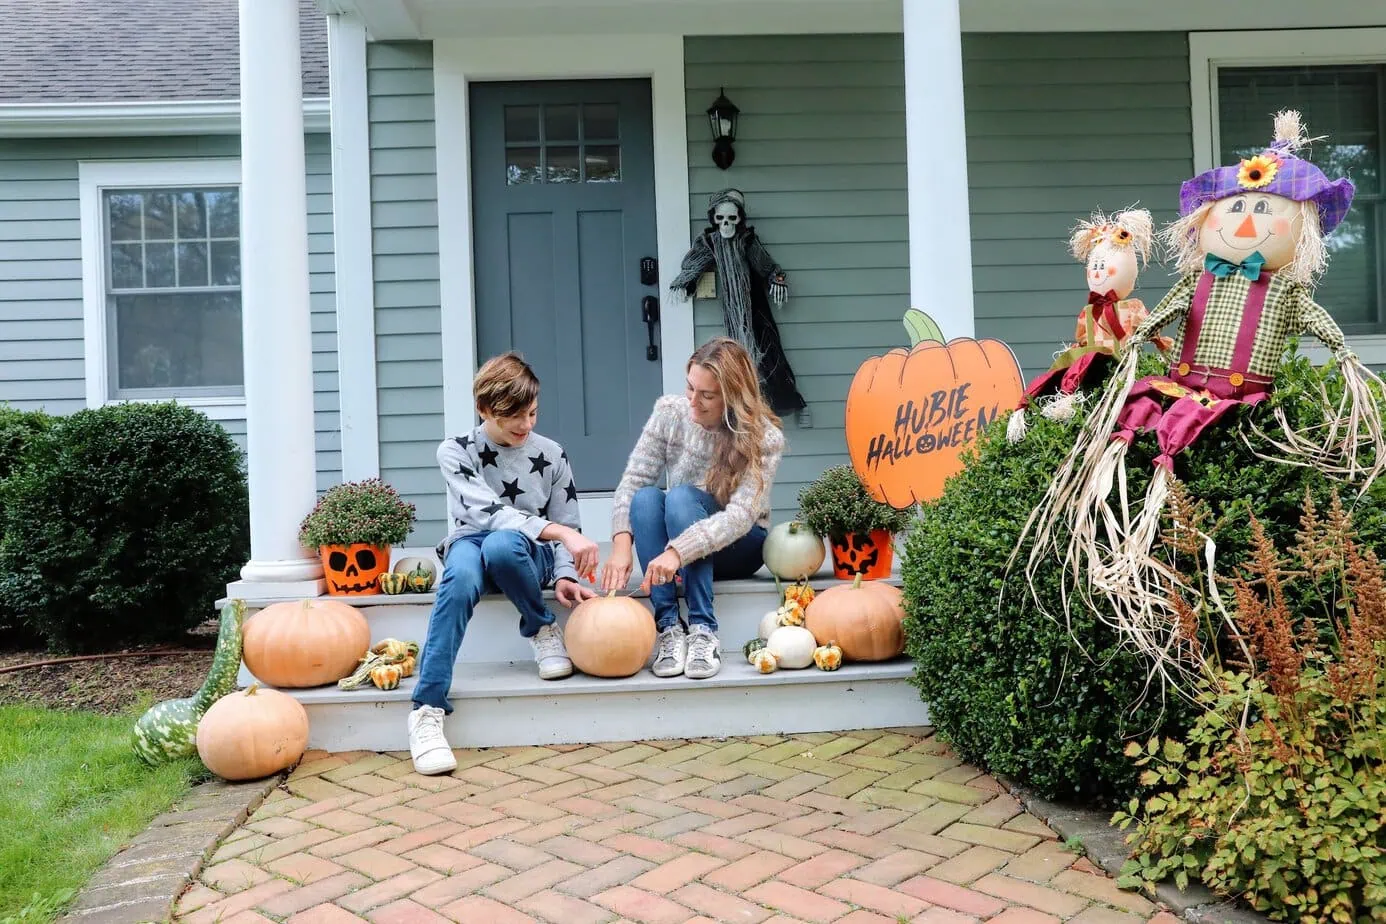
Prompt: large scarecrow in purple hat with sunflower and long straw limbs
<box><xmin>1026</xmin><ymin>111</ymin><xmax>1386</xmax><ymax>667</ymax></box>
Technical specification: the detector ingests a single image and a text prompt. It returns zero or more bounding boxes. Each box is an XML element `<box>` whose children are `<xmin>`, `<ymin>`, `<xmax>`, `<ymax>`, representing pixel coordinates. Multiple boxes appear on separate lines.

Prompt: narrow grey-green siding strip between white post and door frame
<box><xmin>366</xmin><ymin>43</ymin><xmax>443</xmax><ymax>544</ymax></box>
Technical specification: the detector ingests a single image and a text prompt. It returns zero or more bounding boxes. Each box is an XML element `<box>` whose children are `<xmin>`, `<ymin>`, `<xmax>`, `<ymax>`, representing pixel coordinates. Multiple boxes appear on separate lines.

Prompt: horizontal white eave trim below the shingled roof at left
<box><xmin>0</xmin><ymin>98</ymin><xmax>328</xmax><ymax>139</ymax></box>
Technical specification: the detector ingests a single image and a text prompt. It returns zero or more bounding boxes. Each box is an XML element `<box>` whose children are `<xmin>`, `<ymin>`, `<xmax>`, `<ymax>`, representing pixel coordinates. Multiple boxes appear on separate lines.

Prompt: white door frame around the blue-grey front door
<box><xmin>434</xmin><ymin>35</ymin><xmax>694</xmax><ymax>434</ymax></box>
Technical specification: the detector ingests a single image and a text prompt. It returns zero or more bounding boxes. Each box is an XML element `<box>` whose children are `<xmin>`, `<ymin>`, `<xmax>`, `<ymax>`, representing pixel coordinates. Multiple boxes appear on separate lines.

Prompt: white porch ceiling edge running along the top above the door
<box><xmin>316</xmin><ymin>0</ymin><xmax>1386</xmax><ymax>40</ymax></box>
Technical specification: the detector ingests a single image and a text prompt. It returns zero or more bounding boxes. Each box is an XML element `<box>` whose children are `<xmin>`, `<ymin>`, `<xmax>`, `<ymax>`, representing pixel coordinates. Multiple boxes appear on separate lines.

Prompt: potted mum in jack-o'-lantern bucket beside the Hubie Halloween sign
<box><xmin>798</xmin><ymin>465</ymin><xmax>909</xmax><ymax>580</ymax></box>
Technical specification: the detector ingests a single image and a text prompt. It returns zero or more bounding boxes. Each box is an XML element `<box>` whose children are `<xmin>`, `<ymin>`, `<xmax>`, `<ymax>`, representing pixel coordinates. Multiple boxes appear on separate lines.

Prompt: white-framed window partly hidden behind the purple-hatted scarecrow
<box><xmin>1189</xmin><ymin>29</ymin><xmax>1386</xmax><ymax>354</ymax></box>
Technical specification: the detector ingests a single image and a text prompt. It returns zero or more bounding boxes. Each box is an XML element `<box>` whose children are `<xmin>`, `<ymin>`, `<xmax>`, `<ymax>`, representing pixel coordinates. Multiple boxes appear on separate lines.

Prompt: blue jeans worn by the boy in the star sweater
<box><xmin>413</xmin><ymin>529</ymin><xmax>553</xmax><ymax>715</ymax></box>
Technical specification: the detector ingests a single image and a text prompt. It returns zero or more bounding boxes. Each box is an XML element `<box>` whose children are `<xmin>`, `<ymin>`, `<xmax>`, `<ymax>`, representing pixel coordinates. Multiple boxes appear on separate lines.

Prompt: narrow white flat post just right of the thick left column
<box><xmin>327</xmin><ymin>15</ymin><xmax>380</xmax><ymax>481</ymax></box>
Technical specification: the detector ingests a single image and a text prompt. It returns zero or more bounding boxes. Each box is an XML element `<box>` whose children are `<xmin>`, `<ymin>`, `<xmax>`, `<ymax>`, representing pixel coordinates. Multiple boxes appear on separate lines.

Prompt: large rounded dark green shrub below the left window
<box><xmin>0</xmin><ymin>403</ymin><xmax>249</xmax><ymax>651</ymax></box>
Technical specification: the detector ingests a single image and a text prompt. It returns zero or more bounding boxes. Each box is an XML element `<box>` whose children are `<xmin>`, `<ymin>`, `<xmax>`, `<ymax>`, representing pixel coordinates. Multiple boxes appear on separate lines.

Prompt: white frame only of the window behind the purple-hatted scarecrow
<box><xmin>1189</xmin><ymin>28</ymin><xmax>1386</xmax><ymax>364</ymax></box>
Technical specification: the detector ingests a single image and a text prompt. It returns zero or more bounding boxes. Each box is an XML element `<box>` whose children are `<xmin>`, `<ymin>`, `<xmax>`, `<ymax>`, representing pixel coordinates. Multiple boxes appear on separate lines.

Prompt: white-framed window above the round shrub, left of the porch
<box><xmin>80</xmin><ymin>161</ymin><xmax>245</xmax><ymax>416</ymax></box>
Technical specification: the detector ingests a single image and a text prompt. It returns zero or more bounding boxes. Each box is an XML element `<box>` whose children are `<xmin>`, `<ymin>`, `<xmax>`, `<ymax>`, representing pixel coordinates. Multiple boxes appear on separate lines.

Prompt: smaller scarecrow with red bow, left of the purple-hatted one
<box><xmin>1006</xmin><ymin>209</ymin><xmax>1173</xmax><ymax>443</ymax></box>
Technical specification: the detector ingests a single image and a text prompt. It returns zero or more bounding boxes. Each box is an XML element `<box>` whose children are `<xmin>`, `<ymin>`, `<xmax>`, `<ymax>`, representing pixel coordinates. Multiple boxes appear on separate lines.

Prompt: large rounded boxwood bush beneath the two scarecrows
<box><xmin>902</xmin><ymin>350</ymin><xmax>1386</xmax><ymax>802</ymax></box>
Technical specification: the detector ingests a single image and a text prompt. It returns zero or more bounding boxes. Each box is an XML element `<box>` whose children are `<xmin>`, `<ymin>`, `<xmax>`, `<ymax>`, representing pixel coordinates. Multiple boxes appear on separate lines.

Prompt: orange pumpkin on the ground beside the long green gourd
<box><xmin>197</xmin><ymin>683</ymin><xmax>308</xmax><ymax>780</ymax></box>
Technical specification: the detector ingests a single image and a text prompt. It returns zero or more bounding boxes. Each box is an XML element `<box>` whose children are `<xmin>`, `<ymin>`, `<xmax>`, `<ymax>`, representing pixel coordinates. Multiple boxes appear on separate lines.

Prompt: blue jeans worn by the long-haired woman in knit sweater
<box><xmin>631</xmin><ymin>485</ymin><xmax>765</xmax><ymax>632</ymax></box>
